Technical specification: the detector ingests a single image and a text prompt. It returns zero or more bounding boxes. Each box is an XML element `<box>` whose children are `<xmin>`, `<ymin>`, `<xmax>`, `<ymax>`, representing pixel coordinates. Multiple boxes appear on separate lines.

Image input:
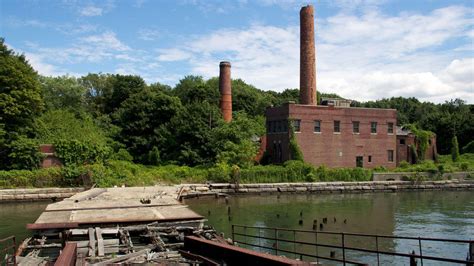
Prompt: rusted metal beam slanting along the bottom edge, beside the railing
<box><xmin>184</xmin><ymin>236</ymin><xmax>310</xmax><ymax>265</ymax></box>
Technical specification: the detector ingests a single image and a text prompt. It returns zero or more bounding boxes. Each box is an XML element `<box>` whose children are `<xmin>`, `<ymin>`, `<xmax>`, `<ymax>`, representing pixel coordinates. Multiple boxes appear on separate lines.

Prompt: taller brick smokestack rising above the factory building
<box><xmin>300</xmin><ymin>5</ymin><xmax>317</xmax><ymax>105</ymax></box>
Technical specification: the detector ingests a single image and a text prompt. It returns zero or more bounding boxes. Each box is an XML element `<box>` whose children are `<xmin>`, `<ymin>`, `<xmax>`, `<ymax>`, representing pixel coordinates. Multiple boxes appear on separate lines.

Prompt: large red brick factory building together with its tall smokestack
<box><xmin>266</xmin><ymin>6</ymin><xmax>398</xmax><ymax>168</ymax></box>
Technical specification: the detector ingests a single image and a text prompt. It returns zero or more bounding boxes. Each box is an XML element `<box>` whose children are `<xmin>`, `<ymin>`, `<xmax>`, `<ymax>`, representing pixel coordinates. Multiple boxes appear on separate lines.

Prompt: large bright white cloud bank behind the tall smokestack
<box><xmin>156</xmin><ymin>3</ymin><xmax>474</xmax><ymax>102</ymax></box>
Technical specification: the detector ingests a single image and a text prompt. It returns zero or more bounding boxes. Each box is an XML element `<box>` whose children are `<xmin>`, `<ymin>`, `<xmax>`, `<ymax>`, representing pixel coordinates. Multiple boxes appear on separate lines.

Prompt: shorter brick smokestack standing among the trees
<box><xmin>219</xmin><ymin>61</ymin><xmax>232</xmax><ymax>122</ymax></box>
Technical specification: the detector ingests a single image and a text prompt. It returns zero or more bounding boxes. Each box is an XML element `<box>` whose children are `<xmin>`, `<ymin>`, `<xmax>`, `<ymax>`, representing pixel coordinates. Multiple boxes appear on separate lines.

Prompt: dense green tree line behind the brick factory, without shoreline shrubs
<box><xmin>0</xmin><ymin>39</ymin><xmax>474</xmax><ymax>169</ymax></box>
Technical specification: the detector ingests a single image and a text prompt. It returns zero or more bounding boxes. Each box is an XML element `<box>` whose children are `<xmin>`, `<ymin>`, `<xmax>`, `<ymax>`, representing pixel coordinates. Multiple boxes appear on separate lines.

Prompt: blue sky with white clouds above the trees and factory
<box><xmin>0</xmin><ymin>0</ymin><xmax>474</xmax><ymax>104</ymax></box>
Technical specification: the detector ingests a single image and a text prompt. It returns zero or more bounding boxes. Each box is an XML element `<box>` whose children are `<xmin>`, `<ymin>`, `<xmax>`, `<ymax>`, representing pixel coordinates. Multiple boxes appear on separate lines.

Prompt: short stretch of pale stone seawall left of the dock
<box><xmin>0</xmin><ymin>188</ymin><xmax>85</xmax><ymax>202</ymax></box>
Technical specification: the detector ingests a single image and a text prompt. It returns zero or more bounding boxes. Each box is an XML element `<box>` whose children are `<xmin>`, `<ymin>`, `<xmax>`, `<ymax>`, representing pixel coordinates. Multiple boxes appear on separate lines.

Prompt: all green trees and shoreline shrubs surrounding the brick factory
<box><xmin>0</xmin><ymin>39</ymin><xmax>474</xmax><ymax>187</ymax></box>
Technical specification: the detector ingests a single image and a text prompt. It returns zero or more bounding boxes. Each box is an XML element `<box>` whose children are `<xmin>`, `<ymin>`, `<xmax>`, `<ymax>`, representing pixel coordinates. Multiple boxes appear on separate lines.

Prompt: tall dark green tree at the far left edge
<box><xmin>0</xmin><ymin>38</ymin><xmax>43</xmax><ymax>169</ymax></box>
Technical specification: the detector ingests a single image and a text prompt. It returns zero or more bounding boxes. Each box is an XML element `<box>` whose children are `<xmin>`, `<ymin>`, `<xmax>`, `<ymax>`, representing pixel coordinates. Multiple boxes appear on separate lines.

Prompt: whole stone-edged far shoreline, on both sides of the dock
<box><xmin>0</xmin><ymin>179</ymin><xmax>474</xmax><ymax>203</ymax></box>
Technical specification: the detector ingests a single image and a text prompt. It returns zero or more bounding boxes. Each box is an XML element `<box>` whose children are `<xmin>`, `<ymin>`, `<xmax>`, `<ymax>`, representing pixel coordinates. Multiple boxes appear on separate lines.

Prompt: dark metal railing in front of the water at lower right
<box><xmin>232</xmin><ymin>225</ymin><xmax>474</xmax><ymax>266</ymax></box>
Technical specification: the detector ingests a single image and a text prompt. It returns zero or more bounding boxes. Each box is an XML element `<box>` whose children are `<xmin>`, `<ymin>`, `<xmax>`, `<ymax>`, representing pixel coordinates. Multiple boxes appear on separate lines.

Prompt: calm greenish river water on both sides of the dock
<box><xmin>0</xmin><ymin>191</ymin><xmax>474</xmax><ymax>265</ymax></box>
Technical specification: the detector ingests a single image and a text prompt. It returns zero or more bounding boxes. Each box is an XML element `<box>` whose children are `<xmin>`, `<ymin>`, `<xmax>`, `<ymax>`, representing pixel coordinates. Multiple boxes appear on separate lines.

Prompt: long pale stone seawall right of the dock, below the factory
<box><xmin>180</xmin><ymin>180</ymin><xmax>474</xmax><ymax>198</ymax></box>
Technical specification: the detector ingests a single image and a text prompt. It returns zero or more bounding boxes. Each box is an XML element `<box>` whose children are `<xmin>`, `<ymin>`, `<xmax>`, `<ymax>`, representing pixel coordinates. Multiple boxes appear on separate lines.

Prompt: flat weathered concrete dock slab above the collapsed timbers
<box><xmin>28</xmin><ymin>186</ymin><xmax>203</xmax><ymax>230</ymax></box>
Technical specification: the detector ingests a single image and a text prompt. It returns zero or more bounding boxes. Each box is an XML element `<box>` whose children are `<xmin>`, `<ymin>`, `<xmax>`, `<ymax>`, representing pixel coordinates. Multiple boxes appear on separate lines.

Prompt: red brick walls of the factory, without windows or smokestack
<box><xmin>267</xmin><ymin>104</ymin><xmax>397</xmax><ymax>168</ymax></box>
